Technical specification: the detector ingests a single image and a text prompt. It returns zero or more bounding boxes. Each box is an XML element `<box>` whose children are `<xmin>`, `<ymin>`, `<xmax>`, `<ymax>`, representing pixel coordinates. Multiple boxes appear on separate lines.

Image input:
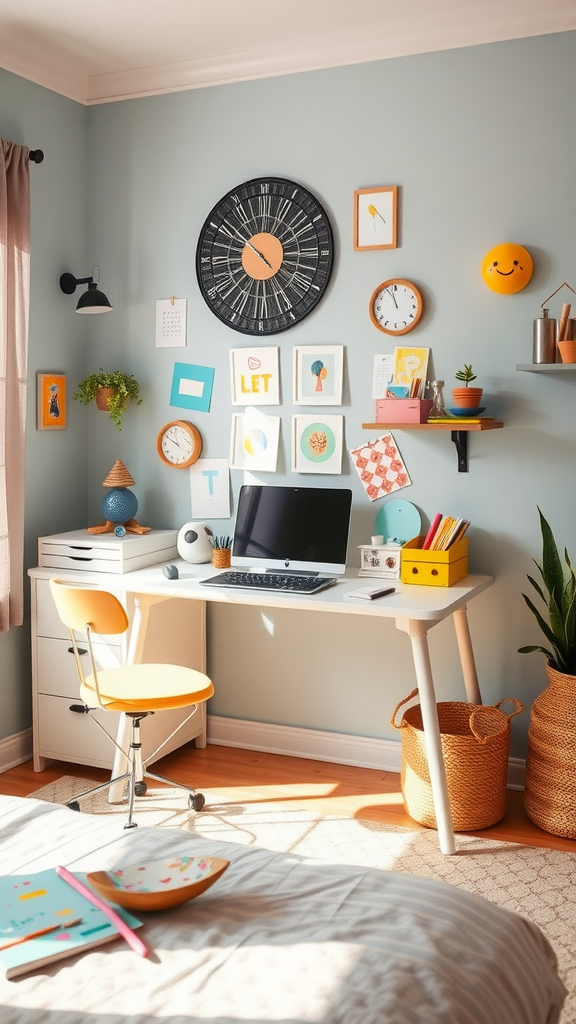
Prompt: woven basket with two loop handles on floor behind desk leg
<box><xmin>390</xmin><ymin>690</ymin><xmax>524</xmax><ymax>831</ymax></box>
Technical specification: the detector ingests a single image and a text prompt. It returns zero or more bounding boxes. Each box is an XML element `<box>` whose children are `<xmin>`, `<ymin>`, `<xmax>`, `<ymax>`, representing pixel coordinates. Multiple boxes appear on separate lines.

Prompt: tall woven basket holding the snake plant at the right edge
<box><xmin>524</xmin><ymin>665</ymin><xmax>576</xmax><ymax>839</ymax></box>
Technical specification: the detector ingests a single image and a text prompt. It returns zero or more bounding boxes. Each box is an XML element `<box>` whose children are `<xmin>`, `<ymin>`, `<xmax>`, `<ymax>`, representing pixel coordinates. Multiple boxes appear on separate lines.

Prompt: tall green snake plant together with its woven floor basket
<box><xmin>519</xmin><ymin>509</ymin><xmax>576</xmax><ymax>839</ymax></box>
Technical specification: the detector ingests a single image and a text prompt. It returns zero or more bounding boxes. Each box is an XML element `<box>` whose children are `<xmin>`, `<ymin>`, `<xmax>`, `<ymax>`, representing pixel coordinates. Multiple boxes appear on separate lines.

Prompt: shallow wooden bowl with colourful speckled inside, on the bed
<box><xmin>86</xmin><ymin>854</ymin><xmax>230</xmax><ymax>910</ymax></box>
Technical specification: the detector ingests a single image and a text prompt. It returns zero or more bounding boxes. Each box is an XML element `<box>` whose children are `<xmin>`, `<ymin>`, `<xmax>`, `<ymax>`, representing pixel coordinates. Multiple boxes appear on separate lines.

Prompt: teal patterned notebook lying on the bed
<box><xmin>0</xmin><ymin>868</ymin><xmax>141</xmax><ymax>978</ymax></box>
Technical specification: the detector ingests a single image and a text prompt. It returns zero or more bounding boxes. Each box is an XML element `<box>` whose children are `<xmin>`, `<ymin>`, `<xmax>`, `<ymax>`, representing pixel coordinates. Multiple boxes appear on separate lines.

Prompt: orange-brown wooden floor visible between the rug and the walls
<box><xmin>0</xmin><ymin>743</ymin><xmax>576</xmax><ymax>853</ymax></box>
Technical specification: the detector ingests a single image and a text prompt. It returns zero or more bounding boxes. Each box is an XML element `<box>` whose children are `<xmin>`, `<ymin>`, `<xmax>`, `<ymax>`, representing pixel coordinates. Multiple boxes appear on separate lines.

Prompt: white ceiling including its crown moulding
<box><xmin>0</xmin><ymin>0</ymin><xmax>576</xmax><ymax>104</ymax></box>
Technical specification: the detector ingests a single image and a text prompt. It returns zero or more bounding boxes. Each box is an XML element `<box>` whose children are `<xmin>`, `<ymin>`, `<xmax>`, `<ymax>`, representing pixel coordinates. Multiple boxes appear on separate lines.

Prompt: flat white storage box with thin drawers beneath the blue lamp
<box><xmin>38</xmin><ymin>529</ymin><xmax>178</xmax><ymax>573</ymax></box>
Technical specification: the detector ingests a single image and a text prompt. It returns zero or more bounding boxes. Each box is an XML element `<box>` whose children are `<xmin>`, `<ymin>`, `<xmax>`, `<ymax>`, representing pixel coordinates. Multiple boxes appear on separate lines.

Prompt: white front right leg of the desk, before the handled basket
<box><xmin>396</xmin><ymin>618</ymin><xmax>456</xmax><ymax>854</ymax></box>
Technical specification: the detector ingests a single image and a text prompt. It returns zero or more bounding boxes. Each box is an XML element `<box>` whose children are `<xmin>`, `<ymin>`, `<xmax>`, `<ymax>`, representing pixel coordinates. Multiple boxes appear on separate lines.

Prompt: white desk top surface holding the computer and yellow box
<box><xmin>30</xmin><ymin>559</ymin><xmax>493</xmax><ymax>622</ymax></box>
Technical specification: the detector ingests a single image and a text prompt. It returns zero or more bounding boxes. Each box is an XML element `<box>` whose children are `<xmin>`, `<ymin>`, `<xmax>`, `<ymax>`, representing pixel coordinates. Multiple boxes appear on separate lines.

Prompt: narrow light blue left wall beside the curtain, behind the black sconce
<box><xmin>0</xmin><ymin>69</ymin><xmax>88</xmax><ymax>739</ymax></box>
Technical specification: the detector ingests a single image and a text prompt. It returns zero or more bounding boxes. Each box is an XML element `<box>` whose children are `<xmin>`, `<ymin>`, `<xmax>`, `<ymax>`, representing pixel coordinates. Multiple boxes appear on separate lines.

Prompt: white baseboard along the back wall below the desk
<box><xmin>207</xmin><ymin>715</ymin><xmax>526</xmax><ymax>790</ymax></box>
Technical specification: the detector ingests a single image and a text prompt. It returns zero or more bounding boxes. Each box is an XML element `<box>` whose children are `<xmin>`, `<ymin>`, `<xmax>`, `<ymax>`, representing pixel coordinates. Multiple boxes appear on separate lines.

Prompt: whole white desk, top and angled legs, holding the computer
<box><xmin>30</xmin><ymin>560</ymin><xmax>492</xmax><ymax>854</ymax></box>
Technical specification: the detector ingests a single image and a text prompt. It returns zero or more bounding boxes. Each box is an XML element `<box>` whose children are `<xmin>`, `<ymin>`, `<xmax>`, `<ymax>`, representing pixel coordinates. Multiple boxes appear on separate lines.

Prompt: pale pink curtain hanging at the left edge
<box><xmin>0</xmin><ymin>139</ymin><xmax>30</xmax><ymax>633</ymax></box>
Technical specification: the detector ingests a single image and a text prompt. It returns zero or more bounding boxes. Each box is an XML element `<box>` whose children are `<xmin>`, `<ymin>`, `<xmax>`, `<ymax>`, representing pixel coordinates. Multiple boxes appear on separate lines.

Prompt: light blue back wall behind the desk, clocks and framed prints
<box><xmin>0</xmin><ymin>33</ymin><xmax>576</xmax><ymax>756</ymax></box>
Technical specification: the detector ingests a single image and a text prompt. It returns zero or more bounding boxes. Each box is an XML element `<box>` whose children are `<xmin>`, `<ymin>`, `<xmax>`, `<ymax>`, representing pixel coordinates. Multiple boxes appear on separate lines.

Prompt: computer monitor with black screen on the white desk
<box><xmin>232</xmin><ymin>484</ymin><xmax>352</xmax><ymax>574</ymax></box>
